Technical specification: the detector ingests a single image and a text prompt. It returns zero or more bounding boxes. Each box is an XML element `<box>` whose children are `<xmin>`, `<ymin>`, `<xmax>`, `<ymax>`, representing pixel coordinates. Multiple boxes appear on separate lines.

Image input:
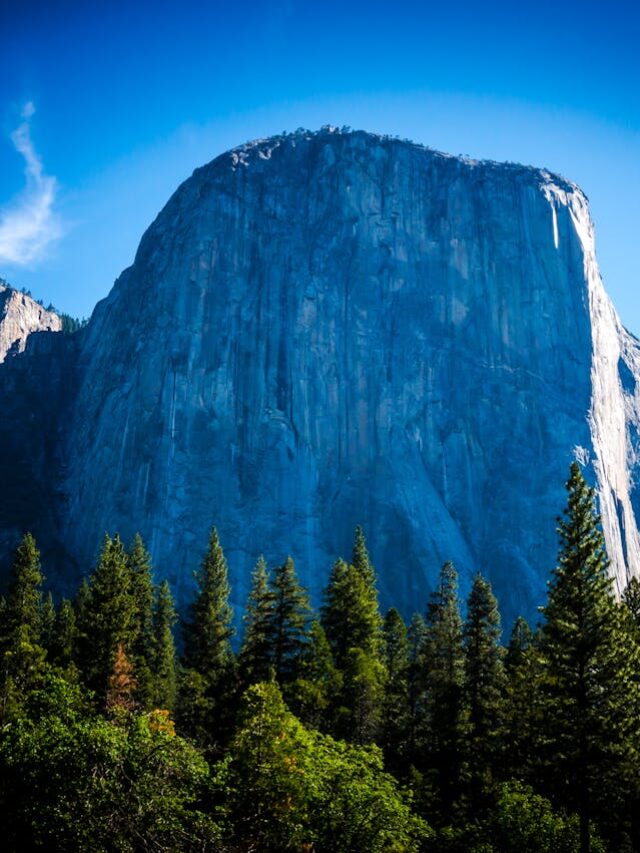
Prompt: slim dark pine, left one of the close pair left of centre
<box><xmin>238</xmin><ymin>556</ymin><xmax>274</xmax><ymax>686</ymax></box>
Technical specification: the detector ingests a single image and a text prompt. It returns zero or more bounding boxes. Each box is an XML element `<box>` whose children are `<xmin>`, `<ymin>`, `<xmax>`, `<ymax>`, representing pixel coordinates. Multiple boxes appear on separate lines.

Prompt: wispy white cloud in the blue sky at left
<box><xmin>0</xmin><ymin>101</ymin><xmax>62</xmax><ymax>266</ymax></box>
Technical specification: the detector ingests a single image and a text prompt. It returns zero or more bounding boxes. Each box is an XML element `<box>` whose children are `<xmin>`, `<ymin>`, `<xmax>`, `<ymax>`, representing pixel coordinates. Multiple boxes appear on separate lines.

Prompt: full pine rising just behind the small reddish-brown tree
<box><xmin>77</xmin><ymin>534</ymin><xmax>135</xmax><ymax>702</ymax></box>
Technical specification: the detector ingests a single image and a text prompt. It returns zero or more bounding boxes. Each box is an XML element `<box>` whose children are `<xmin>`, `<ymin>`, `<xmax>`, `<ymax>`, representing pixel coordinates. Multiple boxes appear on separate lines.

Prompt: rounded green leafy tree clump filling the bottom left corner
<box><xmin>0</xmin><ymin>676</ymin><xmax>217</xmax><ymax>853</ymax></box>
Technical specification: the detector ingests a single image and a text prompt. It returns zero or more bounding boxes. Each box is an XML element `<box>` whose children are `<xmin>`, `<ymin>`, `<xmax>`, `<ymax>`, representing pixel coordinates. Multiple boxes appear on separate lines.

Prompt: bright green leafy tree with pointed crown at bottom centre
<box><xmin>216</xmin><ymin>683</ymin><xmax>429</xmax><ymax>853</ymax></box>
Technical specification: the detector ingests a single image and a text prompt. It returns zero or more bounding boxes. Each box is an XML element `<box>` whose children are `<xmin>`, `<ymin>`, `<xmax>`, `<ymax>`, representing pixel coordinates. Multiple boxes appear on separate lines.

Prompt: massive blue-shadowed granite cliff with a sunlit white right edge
<box><xmin>0</xmin><ymin>129</ymin><xmax>640</xmax><ymax>620</ymax></box>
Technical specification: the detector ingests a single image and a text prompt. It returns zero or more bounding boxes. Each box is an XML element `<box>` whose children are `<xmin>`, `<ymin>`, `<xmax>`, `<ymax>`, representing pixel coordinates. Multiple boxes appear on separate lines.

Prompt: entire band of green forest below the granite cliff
<box><xmin>0</xmin><ymin>463</ymin><xmax>640</xmax><ymax>853</ymax></box>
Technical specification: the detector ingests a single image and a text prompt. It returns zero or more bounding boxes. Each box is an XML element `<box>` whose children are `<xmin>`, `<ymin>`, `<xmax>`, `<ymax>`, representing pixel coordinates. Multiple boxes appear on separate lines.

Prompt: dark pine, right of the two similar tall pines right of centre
<box><xmin>463</xmin><ymin>574</ymin><xmax>504</xmax><ymax>795</ymax></box>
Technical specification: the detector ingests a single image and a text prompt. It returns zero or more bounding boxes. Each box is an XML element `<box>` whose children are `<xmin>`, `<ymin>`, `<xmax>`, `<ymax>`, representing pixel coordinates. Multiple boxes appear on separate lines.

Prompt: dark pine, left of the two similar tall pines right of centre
<box><xmin>418</xmin><ymin>562</ymin><xmax>467</xmax><ymax>819</ymax></box>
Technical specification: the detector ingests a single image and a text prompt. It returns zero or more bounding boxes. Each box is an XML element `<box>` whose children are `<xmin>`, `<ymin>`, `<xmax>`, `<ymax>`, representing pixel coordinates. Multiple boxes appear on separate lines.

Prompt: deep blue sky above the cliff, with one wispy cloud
<box><xmin>0</xmin><ymin>0</ymin><xmax>640</xmax><ymax>333</ymax></box>
